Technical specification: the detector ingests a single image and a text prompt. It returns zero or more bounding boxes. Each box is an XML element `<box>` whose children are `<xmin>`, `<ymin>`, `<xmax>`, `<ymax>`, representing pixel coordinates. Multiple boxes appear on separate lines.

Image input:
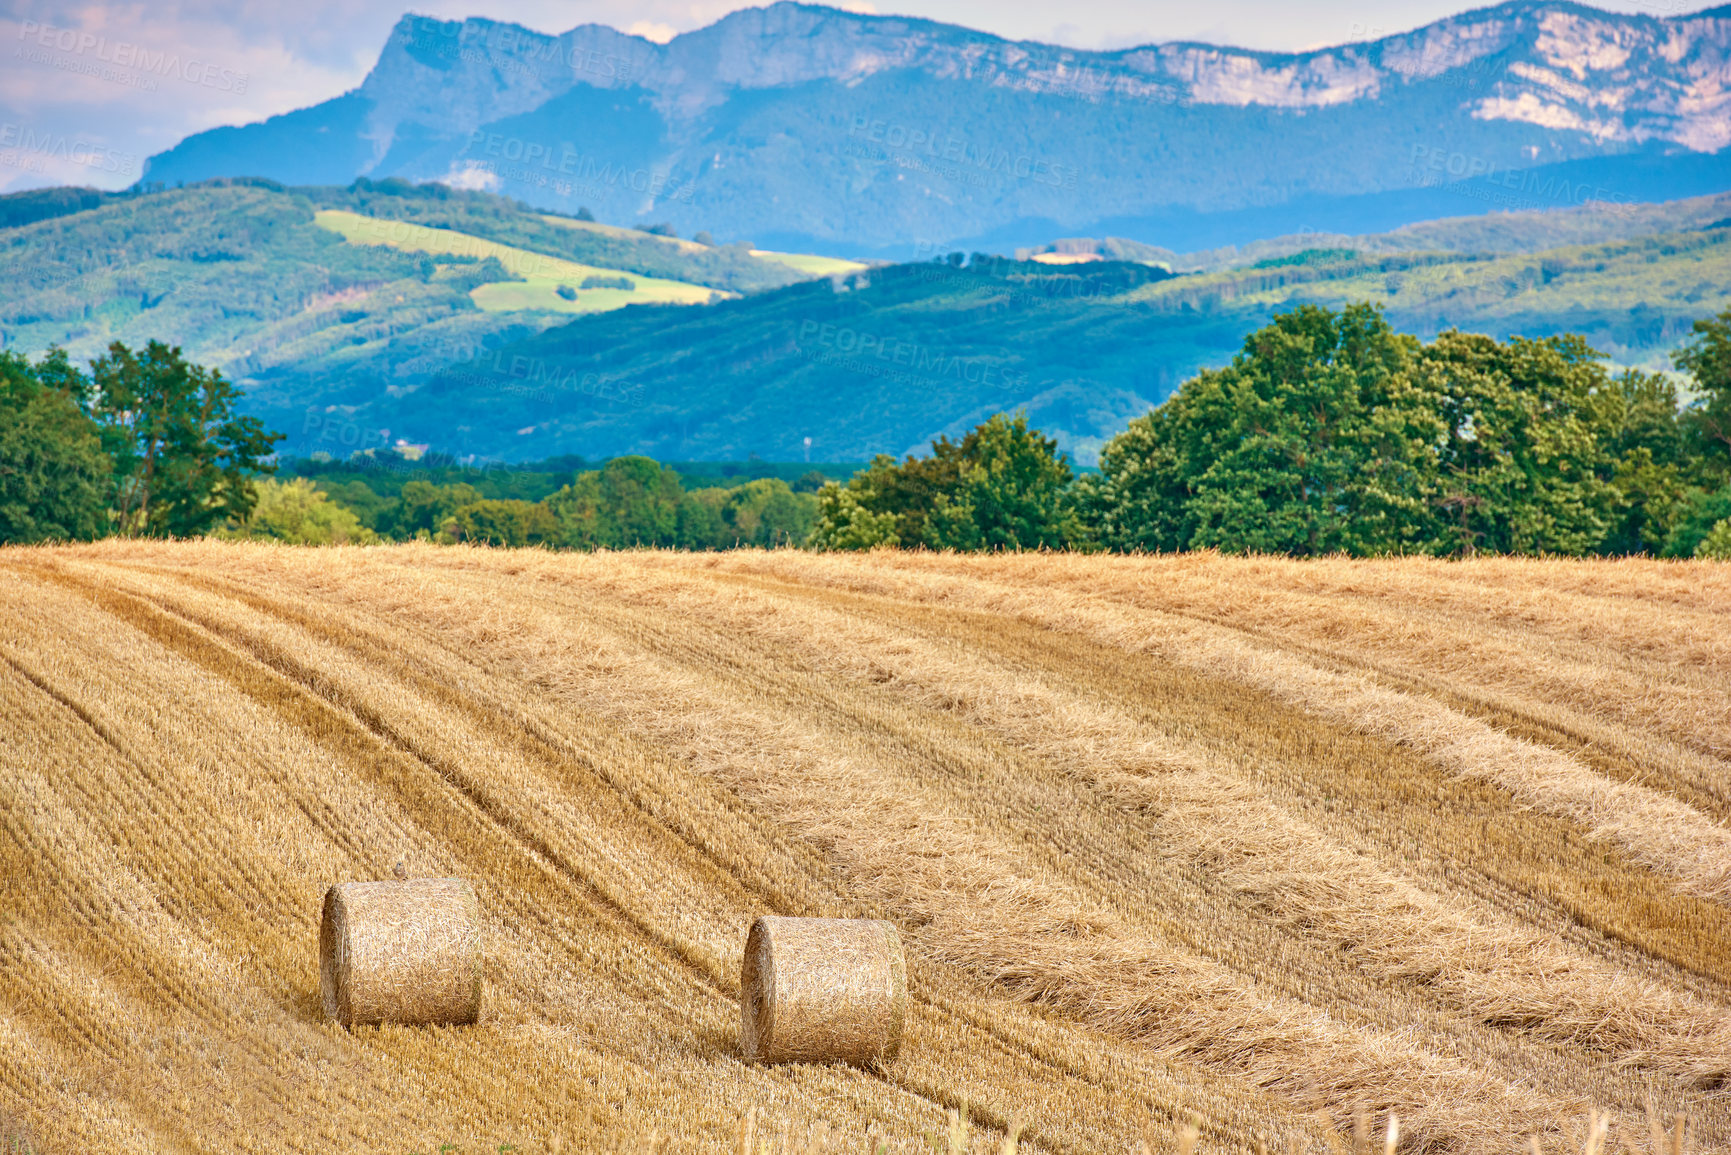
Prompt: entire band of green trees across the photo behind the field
<box><xmin>0</xmin><ymin>305</ymin><xmax>1731</xmax><ymax>558</ymax></box>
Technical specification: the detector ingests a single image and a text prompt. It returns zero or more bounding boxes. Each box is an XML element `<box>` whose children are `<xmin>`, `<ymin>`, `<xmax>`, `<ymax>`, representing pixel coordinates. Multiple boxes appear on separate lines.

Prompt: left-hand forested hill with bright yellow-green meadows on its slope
<box><xmin>0</xmin><ymin>180</ymin><xmax>830</xmax><ymax>427</ymax></box>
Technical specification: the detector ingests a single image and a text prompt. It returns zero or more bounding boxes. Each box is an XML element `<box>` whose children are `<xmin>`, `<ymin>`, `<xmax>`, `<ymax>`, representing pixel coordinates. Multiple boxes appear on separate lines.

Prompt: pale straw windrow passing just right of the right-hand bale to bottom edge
<box><xmin>337</xmin><ymin>557</ymin><xmax>1585</xmax><ymax>1146</ymax></box>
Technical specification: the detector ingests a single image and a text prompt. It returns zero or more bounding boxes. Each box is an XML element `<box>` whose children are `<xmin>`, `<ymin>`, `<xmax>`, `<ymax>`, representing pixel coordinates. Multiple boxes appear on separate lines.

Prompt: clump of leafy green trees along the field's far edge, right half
<box><xmin>812</xmin><ymin>305</ymin><xmax>1731</xmax><ymax>558</ymax></box>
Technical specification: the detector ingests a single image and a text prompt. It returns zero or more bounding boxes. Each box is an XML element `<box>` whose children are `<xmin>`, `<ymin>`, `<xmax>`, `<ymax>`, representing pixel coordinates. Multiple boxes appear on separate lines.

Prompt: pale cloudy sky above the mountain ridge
<box><xmin>0</xmin><ymin>0</ymin><xmax>1707</xmax><ymax>192</ymax></box>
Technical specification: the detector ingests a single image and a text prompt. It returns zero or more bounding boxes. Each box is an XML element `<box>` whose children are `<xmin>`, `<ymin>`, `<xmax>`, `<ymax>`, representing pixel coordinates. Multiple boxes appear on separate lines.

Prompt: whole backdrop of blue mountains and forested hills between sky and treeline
<box><xmin>0</xmin><ymin>0</ymin><xmax>1731</xmax><ymax>462</ymax></box>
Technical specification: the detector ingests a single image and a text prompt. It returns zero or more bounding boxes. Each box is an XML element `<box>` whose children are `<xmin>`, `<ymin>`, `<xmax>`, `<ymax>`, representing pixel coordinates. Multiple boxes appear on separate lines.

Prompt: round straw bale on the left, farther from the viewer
<box><xmin>319</xmin><ymin>878</ymin><xmax>481</xmax><ymax>1027</ymax></box>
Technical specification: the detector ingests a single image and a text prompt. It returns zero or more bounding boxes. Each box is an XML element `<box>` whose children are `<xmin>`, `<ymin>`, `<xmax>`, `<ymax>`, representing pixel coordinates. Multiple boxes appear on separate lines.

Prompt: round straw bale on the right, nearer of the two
<box><xmin>739</xmin><ymin>916</ymin><xmax>907</xmax><ymax>1065</ymax></box>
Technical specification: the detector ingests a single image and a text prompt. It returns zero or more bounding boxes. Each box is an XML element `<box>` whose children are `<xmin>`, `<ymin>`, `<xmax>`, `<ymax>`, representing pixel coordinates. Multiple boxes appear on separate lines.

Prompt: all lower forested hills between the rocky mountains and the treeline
<box><xmin>0</xmin><ymin>182</ymin><xmax>1731</xmax><ymax>461</ymax></box>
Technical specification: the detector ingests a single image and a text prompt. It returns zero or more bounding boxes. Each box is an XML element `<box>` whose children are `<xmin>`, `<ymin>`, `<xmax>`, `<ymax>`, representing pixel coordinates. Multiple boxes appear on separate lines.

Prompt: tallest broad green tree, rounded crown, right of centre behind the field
<box><xmin>1085</xmin><ymin>305</ymin><xmax>1442</xmax><ymax>554</ymax></box>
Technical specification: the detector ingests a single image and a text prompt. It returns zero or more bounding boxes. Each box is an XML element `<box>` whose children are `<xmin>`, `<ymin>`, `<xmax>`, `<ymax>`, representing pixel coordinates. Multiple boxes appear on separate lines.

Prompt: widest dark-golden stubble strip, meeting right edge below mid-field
<box><xmin>709</xmin><ymin>567</ymin><xmax>1731</xmax><ymax>1004</ymax></box>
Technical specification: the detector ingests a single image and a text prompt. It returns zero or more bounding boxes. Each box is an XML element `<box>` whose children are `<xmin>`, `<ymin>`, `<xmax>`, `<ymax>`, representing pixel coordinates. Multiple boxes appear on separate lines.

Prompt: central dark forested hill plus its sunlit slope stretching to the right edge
<box><xmin>321</xmin><ymin>229</ymin><xmax>1731</xmax><ymax>462</ymax></box>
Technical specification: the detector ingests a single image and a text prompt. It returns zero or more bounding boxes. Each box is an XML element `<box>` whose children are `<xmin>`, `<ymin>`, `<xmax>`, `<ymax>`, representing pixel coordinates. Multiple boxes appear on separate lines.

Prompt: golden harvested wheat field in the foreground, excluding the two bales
<box><xmin>0</xmin><ymin>542</ymin><xmax>1731</xmax><ymax>1155</ymax></box>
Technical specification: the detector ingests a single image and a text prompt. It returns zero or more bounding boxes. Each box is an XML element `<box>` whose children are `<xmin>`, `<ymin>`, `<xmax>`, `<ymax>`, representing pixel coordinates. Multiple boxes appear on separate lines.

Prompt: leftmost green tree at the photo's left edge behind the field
<box><xmin>0</xmin><ymin>350</ymin><xmax>113</xmax><ymax>542</ymax></box>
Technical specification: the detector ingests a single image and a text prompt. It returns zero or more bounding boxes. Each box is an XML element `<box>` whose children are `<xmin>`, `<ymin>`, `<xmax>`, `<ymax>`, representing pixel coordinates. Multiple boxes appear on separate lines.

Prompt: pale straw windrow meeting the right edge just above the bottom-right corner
<box><xmin>515</xmin><ymin>561</ymin><xmax>1731</xmax><ymax>1135</ymax></box>
